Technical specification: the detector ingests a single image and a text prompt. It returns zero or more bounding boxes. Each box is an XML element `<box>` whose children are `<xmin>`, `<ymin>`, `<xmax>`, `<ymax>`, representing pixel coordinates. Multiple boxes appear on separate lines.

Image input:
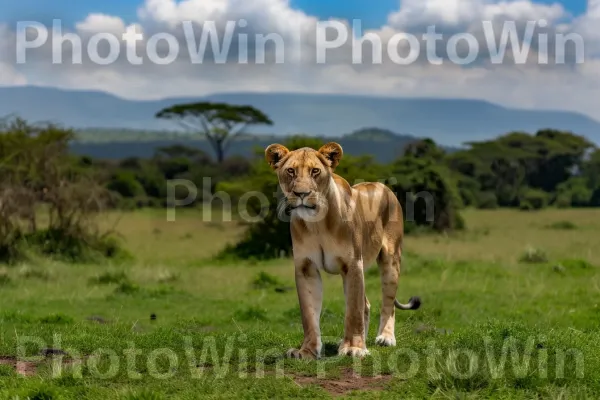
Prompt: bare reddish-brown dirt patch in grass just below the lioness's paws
<box><xmin>293</xmin><ymin>368</ymin><xmax>392</xmax><ymax>396</ymax></box>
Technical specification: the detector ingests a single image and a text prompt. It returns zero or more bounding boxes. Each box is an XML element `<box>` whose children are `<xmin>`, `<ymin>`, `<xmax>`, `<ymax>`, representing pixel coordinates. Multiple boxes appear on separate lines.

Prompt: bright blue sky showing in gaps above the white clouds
<box><xmin>0</xmin><ymin>0</ymin><xmax>586</xmax><ymax>28</ymax></box>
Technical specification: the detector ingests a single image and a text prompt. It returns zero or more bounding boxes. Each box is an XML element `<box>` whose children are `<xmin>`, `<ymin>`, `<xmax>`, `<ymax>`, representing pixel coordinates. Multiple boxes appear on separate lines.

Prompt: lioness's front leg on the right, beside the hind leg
<box><xmin>338</xmin><ymin>261</ymin><xmax>369</xmax><ymax>357</ymax></box>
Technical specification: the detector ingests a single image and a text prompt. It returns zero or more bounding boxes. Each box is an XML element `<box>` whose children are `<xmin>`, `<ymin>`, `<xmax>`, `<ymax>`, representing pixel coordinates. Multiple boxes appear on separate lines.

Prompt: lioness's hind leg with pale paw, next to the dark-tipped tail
<box><xmin>375</xmin><ymin>249</ymin><xmax>400</xmax><ymax>346</ymax></box>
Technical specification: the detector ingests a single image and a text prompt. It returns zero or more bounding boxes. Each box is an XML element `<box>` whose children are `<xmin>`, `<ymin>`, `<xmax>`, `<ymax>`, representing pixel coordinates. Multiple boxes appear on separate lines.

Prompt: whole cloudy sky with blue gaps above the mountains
<box><xmin>0</xmin><ymin>0</ymin><xmax>600</xmax><ymax>120</ymax></box>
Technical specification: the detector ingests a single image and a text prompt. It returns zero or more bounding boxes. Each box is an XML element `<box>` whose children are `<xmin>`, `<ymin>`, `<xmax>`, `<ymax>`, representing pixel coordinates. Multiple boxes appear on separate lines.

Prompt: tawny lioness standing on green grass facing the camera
<box><xmin>265</xmin><ymin>143</ymin><xmax>421</xmax><ymax>359</ymax></box>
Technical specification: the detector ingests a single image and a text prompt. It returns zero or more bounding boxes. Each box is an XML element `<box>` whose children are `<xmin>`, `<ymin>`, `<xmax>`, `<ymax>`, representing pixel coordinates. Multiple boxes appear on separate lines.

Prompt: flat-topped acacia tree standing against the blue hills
<box><xmin>156</xmin><ymin>102</ymin><xmax>273</xmax><ymax>164</ymax></box>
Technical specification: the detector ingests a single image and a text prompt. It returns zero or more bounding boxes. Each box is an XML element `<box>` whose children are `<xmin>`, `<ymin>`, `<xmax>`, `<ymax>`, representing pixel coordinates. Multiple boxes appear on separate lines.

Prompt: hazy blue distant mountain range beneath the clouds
<box><xmin>0</xmin><ymin>86</ymin><xmax>600</xmax><ymax>146</ymax></box>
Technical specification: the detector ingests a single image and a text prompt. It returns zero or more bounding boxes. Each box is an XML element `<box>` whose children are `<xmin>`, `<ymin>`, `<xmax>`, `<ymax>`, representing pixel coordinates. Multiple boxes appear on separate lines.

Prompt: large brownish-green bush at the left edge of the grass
<box><xmin>0</xmin><ymin>118</ymin><xmax>124</xmax><ymax>263</ymax></box>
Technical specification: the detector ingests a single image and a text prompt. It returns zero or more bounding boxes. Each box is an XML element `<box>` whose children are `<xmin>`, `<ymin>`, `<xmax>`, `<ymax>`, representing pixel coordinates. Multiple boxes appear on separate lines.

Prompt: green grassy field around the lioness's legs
<box><xmin>0</xmin><ymin>210</ymin><xmax>600</xmax><ymax>400</ymax></box>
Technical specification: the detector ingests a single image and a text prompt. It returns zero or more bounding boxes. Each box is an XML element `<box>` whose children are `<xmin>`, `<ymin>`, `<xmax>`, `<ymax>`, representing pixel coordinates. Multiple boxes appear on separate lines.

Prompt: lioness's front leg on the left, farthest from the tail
<box><xmin>287</xmin><ymin>259</ymin><xmax>323</xmax><ymax>359</ymax></box>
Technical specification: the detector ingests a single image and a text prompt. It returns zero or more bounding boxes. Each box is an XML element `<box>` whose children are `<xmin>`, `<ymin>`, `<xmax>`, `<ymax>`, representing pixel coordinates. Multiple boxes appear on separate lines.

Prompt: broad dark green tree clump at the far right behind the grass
<box><xmin>446</xmin><ymin>129</ymin><xmax>600</xmax><ymax>209</ymax></box>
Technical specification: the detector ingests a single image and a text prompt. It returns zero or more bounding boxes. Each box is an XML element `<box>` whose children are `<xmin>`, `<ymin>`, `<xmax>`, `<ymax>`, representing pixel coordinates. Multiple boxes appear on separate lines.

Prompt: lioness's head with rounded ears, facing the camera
<box><xmin>265</xmin><ymin>143</ymin><xmax>343</xmax><ymax>216</ymax></box>
